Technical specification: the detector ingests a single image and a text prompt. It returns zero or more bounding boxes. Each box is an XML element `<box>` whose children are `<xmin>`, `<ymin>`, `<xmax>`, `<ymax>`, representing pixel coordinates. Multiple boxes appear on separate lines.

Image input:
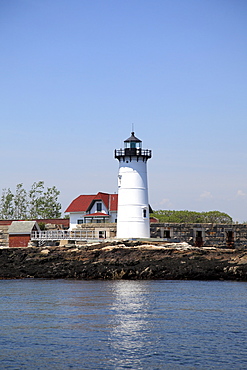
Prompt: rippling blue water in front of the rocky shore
<box><xmin>0</xmin><ymin>280</ymin><xmax>247</xmax><ymax>370</ymax></box>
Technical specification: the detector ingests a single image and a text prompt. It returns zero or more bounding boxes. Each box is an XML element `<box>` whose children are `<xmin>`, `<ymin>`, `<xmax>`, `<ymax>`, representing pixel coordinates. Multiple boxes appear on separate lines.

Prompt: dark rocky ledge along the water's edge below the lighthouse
<box><xmin>0</xmin><ymin>241</ymin><xmax>247</xmax><ymax>281</ymax></box>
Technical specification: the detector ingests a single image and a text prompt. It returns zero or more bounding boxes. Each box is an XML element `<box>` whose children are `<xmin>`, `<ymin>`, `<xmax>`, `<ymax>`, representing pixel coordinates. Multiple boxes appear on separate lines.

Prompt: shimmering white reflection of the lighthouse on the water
<box><xmin>109</xmin><ymin>281</ymin><xmax>149</xmax><ymax>368</ymax></box>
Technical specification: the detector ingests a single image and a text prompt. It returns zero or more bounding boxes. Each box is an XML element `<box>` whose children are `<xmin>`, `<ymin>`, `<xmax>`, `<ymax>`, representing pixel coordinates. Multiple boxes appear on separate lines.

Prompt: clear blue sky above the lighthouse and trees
<box><xmin>0</xmin><ymin>0</ymin><xmax>247</xmax><ymax>222</ymax></box>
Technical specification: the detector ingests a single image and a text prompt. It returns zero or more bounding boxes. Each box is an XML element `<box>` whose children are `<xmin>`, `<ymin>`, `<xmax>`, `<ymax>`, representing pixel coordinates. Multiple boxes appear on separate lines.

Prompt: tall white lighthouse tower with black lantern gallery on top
<box><xmin>115</xmin><ymin>132</ymin><xmax>152</xmax><ymax>239</ymax></box>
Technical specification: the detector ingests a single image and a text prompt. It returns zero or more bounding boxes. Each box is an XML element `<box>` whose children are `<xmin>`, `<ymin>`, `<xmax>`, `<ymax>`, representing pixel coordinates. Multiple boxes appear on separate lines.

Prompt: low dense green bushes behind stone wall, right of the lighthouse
<box><xmin>150</xmin><ymin>210</ymin><xmax>233</xmax><ymax>224</ymax></box>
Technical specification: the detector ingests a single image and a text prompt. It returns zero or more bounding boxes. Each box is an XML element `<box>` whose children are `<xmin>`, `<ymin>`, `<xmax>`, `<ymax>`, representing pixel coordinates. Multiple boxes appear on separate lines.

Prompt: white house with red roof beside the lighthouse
<box><xmin>65</xmin><ymin>192</ymin><xmax>118</xmax><ymax>230</ymax></box>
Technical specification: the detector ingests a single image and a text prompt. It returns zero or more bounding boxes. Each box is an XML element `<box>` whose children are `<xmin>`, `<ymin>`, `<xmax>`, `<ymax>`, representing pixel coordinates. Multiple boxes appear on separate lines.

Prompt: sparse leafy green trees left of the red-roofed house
<box><xmin>0</xmin><ymin>181</ymin><xmax>61</xmax><ymax>220</ymax></box>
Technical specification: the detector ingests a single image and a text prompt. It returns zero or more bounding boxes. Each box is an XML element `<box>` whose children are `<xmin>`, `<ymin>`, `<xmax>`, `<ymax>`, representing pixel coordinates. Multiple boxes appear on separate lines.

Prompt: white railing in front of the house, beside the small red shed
<box><xmin>31</xmin><ymin>230</ymin><xmax>96</xmax><ymax>240</ymax></box>
